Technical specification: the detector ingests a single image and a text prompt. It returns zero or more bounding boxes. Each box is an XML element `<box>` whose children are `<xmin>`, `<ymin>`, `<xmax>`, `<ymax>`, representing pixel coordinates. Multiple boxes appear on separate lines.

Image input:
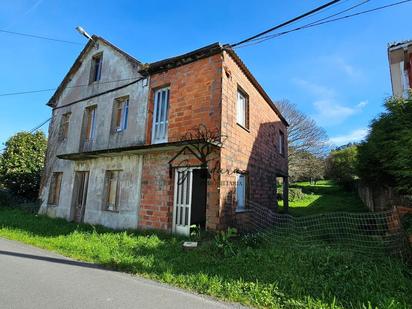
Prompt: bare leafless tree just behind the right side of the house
<box><xmin>277</xmin><ymin>100</ymin><xmax>328</xmax><ymax>180</ymax></box>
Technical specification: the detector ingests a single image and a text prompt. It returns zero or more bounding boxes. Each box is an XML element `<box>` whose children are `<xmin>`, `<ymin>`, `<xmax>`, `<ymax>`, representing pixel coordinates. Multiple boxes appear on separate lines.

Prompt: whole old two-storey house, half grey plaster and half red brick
<box><xmin>40</xmin><ymin>36</ymin><xmax>288</xmax><ymax>235</ymax></box>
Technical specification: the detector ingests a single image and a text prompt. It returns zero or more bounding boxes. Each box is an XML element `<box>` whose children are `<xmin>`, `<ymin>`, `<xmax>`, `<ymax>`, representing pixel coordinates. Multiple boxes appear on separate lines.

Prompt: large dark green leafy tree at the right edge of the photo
<box><xmin>358</xmin><ymin>96</ymin><xmax>412</xmax><ymax>194</ymax></box>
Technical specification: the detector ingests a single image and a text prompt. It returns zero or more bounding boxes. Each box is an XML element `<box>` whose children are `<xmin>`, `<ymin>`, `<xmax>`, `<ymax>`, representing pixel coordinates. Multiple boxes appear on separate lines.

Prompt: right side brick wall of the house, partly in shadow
<box><xmin>220</xmin><ymin>52</ymin><xmax>288</xmax><ymax>227</ymax></box>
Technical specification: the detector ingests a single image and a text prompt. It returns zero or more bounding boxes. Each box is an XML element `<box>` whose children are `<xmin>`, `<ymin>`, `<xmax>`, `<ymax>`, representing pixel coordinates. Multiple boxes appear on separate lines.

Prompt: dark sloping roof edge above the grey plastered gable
<box><xmin>47</xmin><ymin>35</ymin><xmax>142</xmax><ymax>107</ymax></box>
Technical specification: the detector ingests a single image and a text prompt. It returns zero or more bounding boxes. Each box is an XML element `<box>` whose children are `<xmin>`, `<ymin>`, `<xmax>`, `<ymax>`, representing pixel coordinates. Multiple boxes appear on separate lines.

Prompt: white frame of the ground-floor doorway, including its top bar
<box><xmin>172</xmin><ymin>166</ymin><xmax>202</xmax><ymax>236</ymax></box>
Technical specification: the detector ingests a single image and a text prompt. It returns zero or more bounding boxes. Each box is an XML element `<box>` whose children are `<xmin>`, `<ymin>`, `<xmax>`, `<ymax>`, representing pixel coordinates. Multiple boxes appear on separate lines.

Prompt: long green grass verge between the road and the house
<box><xmin>0</xmin><ymin>207</ymin><xmax>412</xmax><ymax>308</ymax></box>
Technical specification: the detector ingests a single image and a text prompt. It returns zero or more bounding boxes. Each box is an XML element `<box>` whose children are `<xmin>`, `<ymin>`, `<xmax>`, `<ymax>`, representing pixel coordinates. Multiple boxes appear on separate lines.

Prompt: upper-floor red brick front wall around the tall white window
<box><xmin>146</xmin><ymin>54</ymin><xmax>222</xmax><ymax>144</ymax></box>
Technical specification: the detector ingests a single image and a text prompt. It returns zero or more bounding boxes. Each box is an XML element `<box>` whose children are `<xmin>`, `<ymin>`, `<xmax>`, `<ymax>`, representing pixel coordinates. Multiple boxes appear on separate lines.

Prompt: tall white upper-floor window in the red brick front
<box><xmin>152</xmin><ymin>87</ymin><xmax>170</xmax><ymax>144</ymax></box>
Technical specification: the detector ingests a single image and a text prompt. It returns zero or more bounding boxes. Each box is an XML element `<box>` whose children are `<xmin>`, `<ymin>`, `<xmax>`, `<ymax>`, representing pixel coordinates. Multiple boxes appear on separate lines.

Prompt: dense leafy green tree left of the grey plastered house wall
<box><xmin>0</xmin><ymin>132</ymin><xmax>47</xmax><ymax>199</ymax></box>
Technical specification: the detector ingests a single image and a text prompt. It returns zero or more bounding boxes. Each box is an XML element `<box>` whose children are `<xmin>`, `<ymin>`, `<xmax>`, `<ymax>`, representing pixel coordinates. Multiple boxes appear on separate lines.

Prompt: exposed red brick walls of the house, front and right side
<box><xmin>139</xmin><ymin>47</ymin><xmax>287</xmax><ymax>230</ymax></box>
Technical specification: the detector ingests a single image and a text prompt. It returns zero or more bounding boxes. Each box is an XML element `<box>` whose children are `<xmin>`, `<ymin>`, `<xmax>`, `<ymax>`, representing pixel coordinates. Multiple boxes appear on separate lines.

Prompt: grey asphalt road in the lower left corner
<box><xmin>0</xmin><ymin>238</ymin><xmax>240</xmax><ymax>309</ymax></box>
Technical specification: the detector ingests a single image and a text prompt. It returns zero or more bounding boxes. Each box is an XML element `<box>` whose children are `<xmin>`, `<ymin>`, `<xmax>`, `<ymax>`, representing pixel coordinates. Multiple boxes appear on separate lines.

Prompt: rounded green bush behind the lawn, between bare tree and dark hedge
<box><xmin>326</xmin><ymin>145</ymin><xmax>358</xmax><ymax>189</ymax></box>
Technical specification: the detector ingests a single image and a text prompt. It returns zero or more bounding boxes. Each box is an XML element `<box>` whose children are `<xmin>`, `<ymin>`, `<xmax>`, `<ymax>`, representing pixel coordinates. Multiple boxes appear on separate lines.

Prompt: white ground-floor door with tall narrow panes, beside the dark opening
<box><xmin>173</xmin><ymin>168</ymin><xmax>193</xmax><ymax>236</ymax></box>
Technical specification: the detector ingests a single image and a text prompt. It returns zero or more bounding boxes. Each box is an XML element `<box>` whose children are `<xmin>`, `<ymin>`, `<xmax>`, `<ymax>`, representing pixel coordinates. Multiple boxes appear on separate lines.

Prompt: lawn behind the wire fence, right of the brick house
<box><xmin>279</xmin><ymin>180</ymin><xmax>368</xmax><ymax>216</ymax></box>
